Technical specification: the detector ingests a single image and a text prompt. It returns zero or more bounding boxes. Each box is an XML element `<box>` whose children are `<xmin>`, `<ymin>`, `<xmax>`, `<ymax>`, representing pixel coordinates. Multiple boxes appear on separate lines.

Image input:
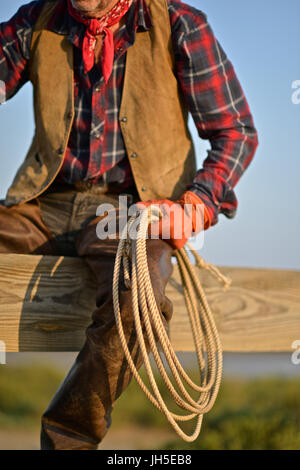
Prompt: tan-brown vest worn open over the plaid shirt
<box><xmin>5</xmin><ymin>0</ymin><xmax>196</xmax><ymax>205</ymax></box>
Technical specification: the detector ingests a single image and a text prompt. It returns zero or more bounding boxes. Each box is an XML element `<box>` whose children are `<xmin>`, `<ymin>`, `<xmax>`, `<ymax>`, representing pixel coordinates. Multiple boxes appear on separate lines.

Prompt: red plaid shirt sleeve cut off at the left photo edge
<box><xmin>0</xmin><ymin>1</ymin><xmax>44</xmax><ymax>100</ymax></box>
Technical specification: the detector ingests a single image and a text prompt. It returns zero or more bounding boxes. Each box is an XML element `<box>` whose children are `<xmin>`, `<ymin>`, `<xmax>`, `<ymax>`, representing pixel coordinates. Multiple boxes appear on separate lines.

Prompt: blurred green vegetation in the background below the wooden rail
<box><xmin>0</xmin><ymin>366</ymin><xmax>300</xmax><ymax>450</ymax></box>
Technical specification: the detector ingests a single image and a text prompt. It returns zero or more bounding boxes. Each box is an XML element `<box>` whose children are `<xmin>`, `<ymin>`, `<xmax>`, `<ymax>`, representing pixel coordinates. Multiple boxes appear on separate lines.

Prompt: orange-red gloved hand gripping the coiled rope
<box><xmin>136</xmin><ymin>191</ymin><xmax>211</xmax><ymax>250</ymax></box>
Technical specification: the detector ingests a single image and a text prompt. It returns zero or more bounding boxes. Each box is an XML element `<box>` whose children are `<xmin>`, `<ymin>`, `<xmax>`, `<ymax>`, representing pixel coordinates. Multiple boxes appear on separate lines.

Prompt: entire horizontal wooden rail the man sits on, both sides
<box><xmin>0</xmin><ymin>255</ymin><xmax>300</xmax><ymax>352</ymax></box>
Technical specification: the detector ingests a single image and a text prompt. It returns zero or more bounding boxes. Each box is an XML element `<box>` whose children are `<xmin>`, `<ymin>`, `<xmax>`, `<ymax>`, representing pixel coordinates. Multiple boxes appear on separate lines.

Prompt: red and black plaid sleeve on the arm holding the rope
<box><xmin>168</xmin><ymin>0</ymin><xmax>258</xmax><ymax>225</ymax></box>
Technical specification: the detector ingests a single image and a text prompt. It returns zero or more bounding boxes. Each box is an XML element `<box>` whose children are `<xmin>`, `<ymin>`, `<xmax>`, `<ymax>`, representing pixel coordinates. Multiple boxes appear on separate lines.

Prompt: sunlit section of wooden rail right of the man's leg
<box><xmin>169</xmin><ymin>268</ymin><xmax>300</xmax><ymax>352</ymax></box>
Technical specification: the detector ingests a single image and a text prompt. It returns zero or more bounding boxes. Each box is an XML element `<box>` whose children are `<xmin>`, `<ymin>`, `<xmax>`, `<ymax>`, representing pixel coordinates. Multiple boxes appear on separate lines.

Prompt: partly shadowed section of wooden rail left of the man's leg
<box><xmin>0</xmin><ymin>255</ymin><xmax>95</xmax><ymax>351</ymax></box>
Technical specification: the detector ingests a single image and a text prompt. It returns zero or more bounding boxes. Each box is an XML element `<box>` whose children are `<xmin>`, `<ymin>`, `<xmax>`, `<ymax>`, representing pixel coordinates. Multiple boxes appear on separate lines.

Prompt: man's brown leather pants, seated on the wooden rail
<box><xmin>0</xmin><ymin>183</ymin><xmax>172</xmax><ymax>450</ymax></box>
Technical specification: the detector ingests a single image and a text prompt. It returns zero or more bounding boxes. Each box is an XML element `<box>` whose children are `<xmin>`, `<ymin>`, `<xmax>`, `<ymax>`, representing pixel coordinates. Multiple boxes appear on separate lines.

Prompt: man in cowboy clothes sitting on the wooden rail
<box><xmin>0</xmin><ymin>0</ymin><xmax>258</xmax><ymax>450</ymax></box>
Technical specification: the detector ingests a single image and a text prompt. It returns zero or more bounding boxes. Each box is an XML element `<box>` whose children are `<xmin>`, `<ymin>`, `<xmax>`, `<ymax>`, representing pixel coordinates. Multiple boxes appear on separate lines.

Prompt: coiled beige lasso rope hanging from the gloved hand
<box><xmin>113</xmin><ymin>206</ymin><xmax>231</xmax><ymax>442</ymax></box>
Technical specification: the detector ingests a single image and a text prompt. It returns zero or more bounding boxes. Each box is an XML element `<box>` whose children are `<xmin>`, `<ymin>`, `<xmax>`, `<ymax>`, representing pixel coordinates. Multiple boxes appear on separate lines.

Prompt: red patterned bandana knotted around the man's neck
<box><xmin>68</xmin><ymin>0</ymin><xmax>133</xmax><ymax>83</ymax></box>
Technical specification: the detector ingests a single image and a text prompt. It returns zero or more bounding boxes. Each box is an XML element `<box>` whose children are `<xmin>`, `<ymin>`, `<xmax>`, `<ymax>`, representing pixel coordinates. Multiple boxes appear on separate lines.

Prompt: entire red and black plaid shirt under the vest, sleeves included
<box><xmin>0</xmin><ymin>0</ymin><xmax>257</xmax><ymax>224</ymax></box>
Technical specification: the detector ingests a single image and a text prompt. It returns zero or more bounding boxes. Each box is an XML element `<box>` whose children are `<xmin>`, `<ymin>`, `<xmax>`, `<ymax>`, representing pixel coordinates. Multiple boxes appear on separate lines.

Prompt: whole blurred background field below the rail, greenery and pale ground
<box><xmin>0</xmin><ymin>354</ymin><xmax>300</xmax><ymax>450</ymax></box>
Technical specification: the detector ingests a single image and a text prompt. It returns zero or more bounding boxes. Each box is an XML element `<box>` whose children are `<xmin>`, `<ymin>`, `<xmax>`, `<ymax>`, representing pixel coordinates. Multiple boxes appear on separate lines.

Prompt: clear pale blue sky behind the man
<box><xmin>0</xmin><ymin>0</ymin><xmax>300</xmax><ymax>269</ymax></box>
